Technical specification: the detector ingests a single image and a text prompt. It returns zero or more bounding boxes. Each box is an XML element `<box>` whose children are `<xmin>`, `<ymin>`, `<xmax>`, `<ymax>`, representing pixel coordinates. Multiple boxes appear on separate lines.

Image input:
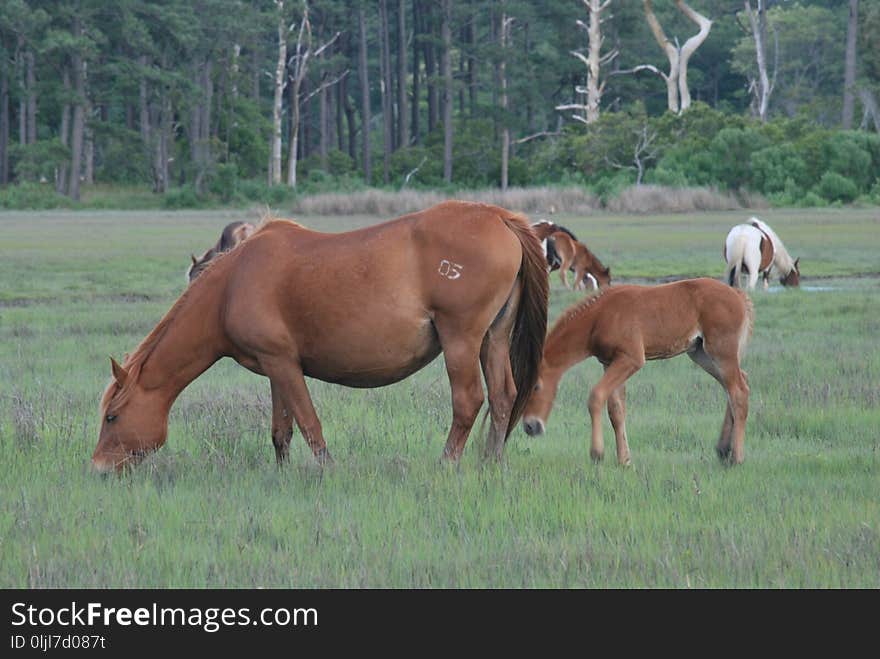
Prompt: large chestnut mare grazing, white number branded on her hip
<box><xmin>92</xmin><ymin>201</ymin><xmax>548</xmax><ymax>471</ymax></box>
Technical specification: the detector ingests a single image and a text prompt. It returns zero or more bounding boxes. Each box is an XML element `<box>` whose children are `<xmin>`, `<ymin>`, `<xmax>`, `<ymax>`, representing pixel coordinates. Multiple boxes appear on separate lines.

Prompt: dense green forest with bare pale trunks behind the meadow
<box><xmin>0</xmin><ymin>0</ymin><xmax>880</xmax><ymax>204</ymax></box>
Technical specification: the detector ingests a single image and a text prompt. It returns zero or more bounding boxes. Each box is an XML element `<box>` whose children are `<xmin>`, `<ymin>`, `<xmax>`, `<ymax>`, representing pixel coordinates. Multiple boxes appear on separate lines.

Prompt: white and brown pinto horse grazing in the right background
<box><xmin>721</xmin><ymin>217</ymin><xmax>801</xmax><ymax>290</ymax></box>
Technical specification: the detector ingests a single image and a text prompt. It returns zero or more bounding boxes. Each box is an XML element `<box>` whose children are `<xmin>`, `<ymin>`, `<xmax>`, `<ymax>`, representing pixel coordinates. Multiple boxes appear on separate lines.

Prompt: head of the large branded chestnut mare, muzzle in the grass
<box><xmin>92</xmin><ymin>357</ymin><xmax>169</xmax><ymax>472</ymax></box>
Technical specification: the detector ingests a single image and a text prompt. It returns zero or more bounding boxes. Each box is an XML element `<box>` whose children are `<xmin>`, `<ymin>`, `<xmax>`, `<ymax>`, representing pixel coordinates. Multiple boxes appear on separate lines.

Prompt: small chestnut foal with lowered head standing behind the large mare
<box><xmin>523</xmin><ymin>279</ymin><xmax>754</xmax><ymax>465</ymax></box>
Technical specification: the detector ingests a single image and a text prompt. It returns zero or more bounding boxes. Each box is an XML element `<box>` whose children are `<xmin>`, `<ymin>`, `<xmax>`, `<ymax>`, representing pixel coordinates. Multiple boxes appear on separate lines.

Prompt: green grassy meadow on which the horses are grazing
<box><xmin>0</xmin><ymin>209</ymin><xmax>880</xmax><ymax>588</ymax></box>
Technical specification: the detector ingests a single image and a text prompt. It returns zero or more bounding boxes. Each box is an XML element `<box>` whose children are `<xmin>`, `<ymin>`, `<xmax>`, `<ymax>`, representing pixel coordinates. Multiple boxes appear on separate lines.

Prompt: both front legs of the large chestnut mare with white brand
<box><xmin>260</xmin><ymin>358</ymin><xmax>333</xmax><ymax>464</ymax></box>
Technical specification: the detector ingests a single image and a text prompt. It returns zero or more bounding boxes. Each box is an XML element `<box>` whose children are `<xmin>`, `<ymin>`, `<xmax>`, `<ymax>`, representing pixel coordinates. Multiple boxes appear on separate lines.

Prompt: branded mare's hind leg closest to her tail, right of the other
<box><xmin>480</xmin><ymin>293</ymin><xmax>519</xmax><ymax>458</ymax></box>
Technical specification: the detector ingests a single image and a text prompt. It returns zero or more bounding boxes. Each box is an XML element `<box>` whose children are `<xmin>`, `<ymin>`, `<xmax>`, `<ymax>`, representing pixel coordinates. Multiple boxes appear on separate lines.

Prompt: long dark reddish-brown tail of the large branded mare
<box><xmin>503</xmin><ymin>216</ymin><xmax>550</xmax><ymax>439</ymax></box>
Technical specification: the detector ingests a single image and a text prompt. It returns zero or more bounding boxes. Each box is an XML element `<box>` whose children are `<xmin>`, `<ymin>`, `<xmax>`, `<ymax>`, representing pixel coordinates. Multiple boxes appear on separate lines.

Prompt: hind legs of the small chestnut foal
<box><xmin>688</xmin><ymin>344</ymin><xmax>749</xmax><ymax>464</ymax></box>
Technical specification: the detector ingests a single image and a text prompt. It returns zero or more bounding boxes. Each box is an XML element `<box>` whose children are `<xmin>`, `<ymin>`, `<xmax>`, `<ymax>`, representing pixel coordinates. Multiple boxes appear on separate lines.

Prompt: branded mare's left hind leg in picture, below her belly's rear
<box><xmin>434</xmin><ymin>316</ymin><xmax>485</xmax><ymax>461</ymax></box>
